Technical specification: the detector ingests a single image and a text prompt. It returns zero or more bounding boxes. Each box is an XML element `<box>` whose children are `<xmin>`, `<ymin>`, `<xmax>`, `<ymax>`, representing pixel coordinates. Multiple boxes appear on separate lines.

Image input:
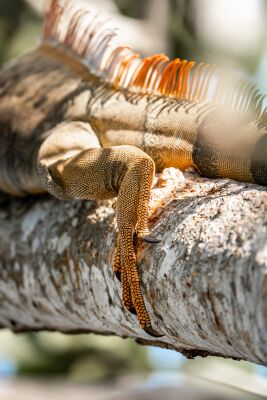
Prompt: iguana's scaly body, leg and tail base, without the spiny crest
<box><xmin>0</xmin><ymin>45</ymin><xmax>267</xmax><ymax>336</ymax></box>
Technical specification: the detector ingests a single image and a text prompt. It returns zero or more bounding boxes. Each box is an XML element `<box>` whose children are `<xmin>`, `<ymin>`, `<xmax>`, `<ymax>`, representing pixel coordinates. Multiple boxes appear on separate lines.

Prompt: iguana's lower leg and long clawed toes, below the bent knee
<box><xmin>114</xmin><ymin>155</ymin><xmax>163</xmax><ymax>337</ymax></box>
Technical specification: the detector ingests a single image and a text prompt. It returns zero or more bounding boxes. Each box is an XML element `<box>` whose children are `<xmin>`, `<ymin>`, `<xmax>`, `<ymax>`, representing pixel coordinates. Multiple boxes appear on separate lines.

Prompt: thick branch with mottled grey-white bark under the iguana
<box><xmin>0</xmin><ymin>169</ymin><xmax>267</xmax><ymax>365</ymax></box>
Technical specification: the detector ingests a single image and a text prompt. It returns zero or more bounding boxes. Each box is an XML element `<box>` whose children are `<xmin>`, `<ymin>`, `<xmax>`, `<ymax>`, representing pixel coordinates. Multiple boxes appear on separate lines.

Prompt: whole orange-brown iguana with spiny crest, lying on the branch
<box><xmin>0</xmin><ymin>0</ymin><xmax>267</xmax><ymax>336</ymax></box>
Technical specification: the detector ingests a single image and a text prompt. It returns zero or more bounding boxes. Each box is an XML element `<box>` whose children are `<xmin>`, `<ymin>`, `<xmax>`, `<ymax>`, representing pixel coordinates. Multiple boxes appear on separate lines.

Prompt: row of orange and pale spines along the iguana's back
<box><xmin>44</xmin><ymin>0</ymin><xmax>265</xmax><ymax>118</ymax></box>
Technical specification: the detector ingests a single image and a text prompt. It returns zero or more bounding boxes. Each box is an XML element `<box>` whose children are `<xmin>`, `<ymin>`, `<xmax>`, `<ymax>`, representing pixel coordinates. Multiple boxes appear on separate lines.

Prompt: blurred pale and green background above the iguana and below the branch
<box><xmin>0</xmin><ymin>0</ymin><xmax>267</xmax><ymax>400</ymax></box>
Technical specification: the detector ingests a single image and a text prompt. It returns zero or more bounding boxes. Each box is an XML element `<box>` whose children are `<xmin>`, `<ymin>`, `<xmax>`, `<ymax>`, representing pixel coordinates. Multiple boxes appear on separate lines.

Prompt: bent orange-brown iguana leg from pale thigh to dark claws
<box><xmin>38</xmin><ymin>122</ymin><xmax>159</xmax><ymax>336</ymax></box>
